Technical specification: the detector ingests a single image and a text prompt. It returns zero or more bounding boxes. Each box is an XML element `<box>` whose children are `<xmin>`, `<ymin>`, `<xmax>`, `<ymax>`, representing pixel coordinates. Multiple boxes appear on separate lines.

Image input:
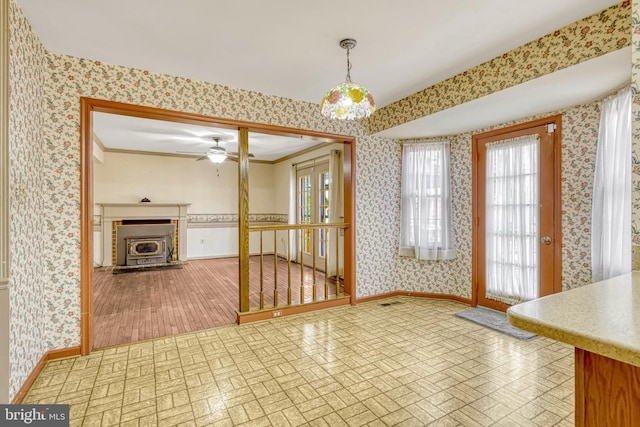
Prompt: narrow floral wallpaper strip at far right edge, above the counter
<box><xmin>631</xmin><ymin>0</ymin><xmax>640</xmax><ymax>270</ymax></box>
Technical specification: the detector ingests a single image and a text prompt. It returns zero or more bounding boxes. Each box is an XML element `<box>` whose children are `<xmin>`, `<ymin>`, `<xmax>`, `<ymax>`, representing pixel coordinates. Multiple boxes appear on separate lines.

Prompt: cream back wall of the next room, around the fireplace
<box><xmin>93</xmin><ymin>152</ymin><xmax>278</xmax><ymax>265</ymax></box>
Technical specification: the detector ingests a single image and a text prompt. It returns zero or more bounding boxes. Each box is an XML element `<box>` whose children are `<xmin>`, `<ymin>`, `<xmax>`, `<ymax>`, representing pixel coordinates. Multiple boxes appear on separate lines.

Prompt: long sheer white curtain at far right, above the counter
<box><xmin>591</xmin><ymin>89</ymin><xmax>632</xmax><ymax>281</ymax></box>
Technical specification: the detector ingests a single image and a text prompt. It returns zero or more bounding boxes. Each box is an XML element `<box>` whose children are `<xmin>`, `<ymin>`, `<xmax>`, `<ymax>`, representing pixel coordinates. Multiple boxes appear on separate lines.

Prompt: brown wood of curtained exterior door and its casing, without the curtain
<box><xmin>472</xmin><ymin>116</ymin><xmax>562</xmax><ymax>311</ymax></box>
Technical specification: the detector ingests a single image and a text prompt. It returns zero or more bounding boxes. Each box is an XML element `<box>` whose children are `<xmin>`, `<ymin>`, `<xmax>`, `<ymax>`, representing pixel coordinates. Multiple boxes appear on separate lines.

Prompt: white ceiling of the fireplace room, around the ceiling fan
<box><xmin>92</xmin><ymin>112</ymin><xmax>327</xmax><ymax>161</ymax></box>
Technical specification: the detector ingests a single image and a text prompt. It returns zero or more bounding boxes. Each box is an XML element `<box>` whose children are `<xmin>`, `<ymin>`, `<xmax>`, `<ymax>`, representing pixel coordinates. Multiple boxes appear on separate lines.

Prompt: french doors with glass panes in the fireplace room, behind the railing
<box><xmin>296</xmin><ymin>162</ymin><xmax>331</xmax><ymax>270</ymax></box>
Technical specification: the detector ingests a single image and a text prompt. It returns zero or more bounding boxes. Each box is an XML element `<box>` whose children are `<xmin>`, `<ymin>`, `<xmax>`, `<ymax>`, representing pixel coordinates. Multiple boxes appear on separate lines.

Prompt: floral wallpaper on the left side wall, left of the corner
<box><xmin>3</xmin><ymin>1</ymin><xmax>48</xmax><ymax>398</ymax></box>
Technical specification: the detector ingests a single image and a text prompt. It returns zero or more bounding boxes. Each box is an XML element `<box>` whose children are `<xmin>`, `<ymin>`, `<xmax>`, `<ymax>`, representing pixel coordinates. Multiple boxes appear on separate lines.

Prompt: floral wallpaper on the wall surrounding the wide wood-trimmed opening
<box><xmin>45</xmin><ymin>53</ymin><xmax>397</xmax><ymax>348</ymax></box>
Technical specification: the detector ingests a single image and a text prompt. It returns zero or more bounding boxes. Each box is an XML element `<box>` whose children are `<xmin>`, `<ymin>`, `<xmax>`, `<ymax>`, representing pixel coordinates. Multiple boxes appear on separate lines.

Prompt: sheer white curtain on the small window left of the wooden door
<box><xmin>400</xmin><ymin>141</ymin><xmax>456</xmax><ymax>260</ymax></box>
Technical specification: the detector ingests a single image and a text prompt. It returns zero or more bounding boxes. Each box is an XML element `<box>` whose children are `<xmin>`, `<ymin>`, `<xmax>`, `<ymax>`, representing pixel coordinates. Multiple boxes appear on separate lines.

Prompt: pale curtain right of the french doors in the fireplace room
<box><xmin>327</xmin><ymin>150</ymin><xmax>343</xmax><ymax>276</ymax></box>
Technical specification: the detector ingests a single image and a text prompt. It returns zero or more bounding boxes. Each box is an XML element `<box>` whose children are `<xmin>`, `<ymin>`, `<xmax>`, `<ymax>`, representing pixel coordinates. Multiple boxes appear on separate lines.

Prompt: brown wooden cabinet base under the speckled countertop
<box><xmin>575</xmin><ymin>348</ymin><xmax>640</xmax><ymax>427</ymax></box>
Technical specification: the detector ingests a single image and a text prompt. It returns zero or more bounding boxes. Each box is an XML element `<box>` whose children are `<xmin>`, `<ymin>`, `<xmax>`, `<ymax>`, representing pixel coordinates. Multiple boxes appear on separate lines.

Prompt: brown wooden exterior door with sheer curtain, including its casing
<box><xmin>473</xmin><ymin>116</ymin><xmax>561</xmax><ymax>311</ymax></box>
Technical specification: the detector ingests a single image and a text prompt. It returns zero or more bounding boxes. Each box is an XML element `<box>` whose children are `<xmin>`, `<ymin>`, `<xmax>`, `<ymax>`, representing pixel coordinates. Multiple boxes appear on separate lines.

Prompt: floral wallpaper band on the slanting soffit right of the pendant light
<box><xmin>365</xmin><ymin>0</ymin><xmax>631</xmax><ymax>133</ymax></box>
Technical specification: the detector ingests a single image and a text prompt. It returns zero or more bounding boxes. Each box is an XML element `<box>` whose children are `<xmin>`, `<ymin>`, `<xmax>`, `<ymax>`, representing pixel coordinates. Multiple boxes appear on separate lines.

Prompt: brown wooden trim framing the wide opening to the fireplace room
<box><xmin>80</xmin><ymin>97</ymin><xmax>356</xmax><ymax>355</ymax></box>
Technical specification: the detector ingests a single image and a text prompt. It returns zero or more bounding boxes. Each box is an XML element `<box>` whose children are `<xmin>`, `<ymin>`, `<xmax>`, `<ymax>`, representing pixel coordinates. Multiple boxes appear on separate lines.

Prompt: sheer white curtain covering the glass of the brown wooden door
<box><xmin>485</xmin><ymin>135</ymin><xmax>540</xmax><ymax>304</ymax></box>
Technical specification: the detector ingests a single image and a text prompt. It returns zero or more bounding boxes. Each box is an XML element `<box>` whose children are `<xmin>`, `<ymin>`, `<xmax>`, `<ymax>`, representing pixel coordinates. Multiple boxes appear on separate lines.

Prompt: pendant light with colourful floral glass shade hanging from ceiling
<box><xmin>320</xmin><ymin>39</ymin><xmax>376</xmax><ymax>120</ymax></box>
